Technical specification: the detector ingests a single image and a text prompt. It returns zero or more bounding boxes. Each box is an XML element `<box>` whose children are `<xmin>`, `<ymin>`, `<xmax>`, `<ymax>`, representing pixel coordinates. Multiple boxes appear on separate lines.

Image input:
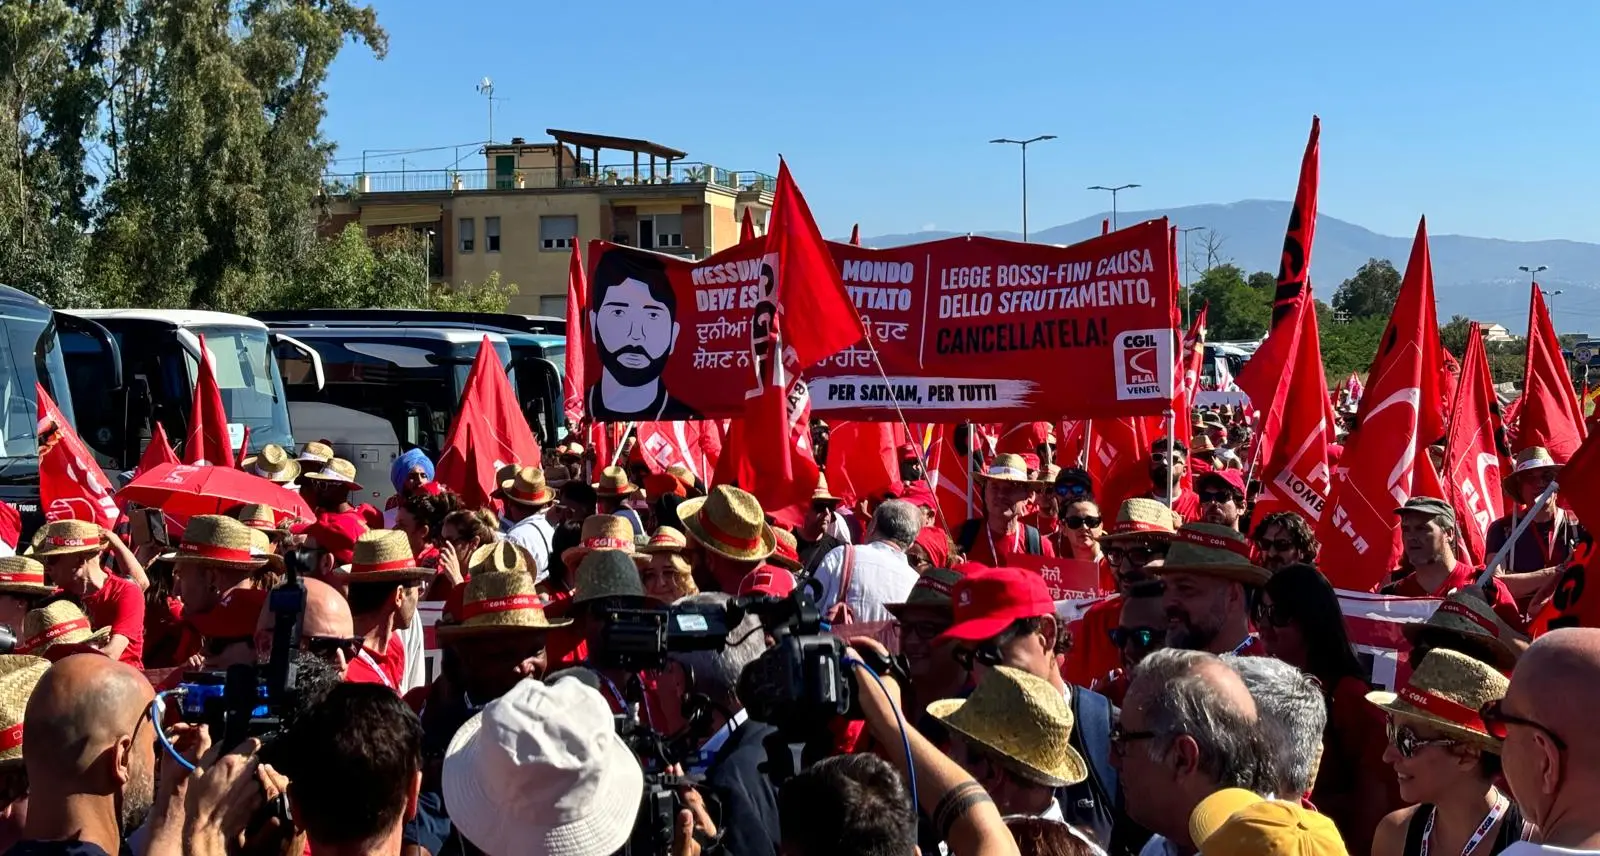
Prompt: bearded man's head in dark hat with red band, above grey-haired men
<box><xmin>1152</xmin><ymin>523</ymin><xmax>1272</xmax><ymax>656</ymax></box>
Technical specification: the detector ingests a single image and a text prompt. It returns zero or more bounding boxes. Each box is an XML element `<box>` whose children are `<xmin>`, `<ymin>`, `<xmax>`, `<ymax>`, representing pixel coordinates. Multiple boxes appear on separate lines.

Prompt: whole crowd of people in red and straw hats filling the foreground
<box><xmin>0</xmin><ymin>411</ymin><xmax>1600</xmax><ymax>856</ymax></box>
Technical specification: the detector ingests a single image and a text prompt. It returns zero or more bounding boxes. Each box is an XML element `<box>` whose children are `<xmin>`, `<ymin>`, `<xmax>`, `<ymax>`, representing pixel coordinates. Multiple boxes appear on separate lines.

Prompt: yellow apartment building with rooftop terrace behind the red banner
<box><xmin>323</xmin><ymin>130</ymin><xmax>776</xmax><ymax>315</ymax></box>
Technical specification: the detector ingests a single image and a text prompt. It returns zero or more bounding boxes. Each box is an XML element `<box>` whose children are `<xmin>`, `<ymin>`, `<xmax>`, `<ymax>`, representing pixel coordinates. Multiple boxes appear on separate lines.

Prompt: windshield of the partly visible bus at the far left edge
<box><xmin>0</xmin><ymin>312</ymin><xmax>75</xmax><ymax>458</ymax></box>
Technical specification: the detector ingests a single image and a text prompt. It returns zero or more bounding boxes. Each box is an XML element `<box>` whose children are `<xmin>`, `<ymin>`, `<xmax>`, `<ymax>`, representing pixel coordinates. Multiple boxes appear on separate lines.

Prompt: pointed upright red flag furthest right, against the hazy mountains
<box><xmin>1517</xmin><ymin>283</ymin><xmax>1584</xmax><ymax>460</ymax></box>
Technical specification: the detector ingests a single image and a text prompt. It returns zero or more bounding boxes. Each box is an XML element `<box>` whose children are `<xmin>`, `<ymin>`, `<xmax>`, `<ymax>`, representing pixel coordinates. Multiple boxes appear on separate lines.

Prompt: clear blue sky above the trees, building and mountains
<box><xmin>325</xmin><ymin>0</ymin><xmax>1600</xmax><ymax>242</ymax></box>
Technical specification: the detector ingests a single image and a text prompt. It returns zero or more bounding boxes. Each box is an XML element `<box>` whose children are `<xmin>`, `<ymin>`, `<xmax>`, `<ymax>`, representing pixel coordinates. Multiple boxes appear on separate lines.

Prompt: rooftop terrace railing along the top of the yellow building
<box><xmin>323</xmin><ymin>162</ymin><xmax>778</xmax><ymax>195</ymax></box>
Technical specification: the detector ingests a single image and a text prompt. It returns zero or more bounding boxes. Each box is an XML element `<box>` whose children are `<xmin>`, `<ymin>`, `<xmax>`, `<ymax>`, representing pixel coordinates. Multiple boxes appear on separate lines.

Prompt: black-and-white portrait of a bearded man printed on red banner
<box><xmin>584</xmin><ymin>248</ymin><xmax>698</xmax><ymax>422</ymax></box>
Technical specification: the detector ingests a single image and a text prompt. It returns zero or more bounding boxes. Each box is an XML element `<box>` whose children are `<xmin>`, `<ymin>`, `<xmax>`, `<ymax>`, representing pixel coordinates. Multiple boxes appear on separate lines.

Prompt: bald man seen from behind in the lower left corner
<box><xmin>11</xmin><ymin>653</ymin><xmax>155</xmax><ymax>856</ymax></box>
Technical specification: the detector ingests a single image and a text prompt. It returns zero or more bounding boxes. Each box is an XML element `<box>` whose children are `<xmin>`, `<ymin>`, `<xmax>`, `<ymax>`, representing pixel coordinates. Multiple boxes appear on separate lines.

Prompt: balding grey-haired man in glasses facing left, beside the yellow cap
<box><xmin>1110</xmin><ymin>648</ymin><xmax>1274</xmax><ymax>856</ymax></box>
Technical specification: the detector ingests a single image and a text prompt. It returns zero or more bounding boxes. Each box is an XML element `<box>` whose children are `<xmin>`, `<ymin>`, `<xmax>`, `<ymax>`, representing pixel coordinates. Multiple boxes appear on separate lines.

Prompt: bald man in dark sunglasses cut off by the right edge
<box><xmin>1497</xmin><ymin>627</ymin><xmax>1600</xmax><ymax>856</ymax></box>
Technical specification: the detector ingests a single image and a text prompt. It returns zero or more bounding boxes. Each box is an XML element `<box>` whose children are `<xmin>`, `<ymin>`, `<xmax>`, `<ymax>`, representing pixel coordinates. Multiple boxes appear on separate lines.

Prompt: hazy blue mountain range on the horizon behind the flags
<box><xmin>861</xmin><ymin>200</ymin><xmax>1600</xmax><ymax>336</ymax></box>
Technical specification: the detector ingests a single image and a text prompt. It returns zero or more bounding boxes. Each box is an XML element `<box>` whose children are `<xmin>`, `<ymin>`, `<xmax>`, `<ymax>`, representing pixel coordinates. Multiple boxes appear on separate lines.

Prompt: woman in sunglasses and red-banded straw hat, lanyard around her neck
<box><xmin>1366</xmin><ymin>651</ymin><xmax>1523</xmax><ymax>856</ymax></box>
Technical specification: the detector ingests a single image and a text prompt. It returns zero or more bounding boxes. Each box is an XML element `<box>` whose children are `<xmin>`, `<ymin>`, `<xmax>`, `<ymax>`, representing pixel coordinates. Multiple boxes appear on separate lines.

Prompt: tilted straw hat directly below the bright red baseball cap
<box><xmin>928</xmin><ymin>666</ymin><xmax>1088</xmax><ymax>787</ymax></box>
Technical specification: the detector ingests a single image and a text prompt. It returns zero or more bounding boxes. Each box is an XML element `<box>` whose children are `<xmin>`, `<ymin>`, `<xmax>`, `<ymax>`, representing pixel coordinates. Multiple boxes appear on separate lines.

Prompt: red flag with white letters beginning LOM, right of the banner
<box><xmin>1253</xmin><ymin>291</ymin><xmax>1333</xmax><ymax>523</ymax></box>
